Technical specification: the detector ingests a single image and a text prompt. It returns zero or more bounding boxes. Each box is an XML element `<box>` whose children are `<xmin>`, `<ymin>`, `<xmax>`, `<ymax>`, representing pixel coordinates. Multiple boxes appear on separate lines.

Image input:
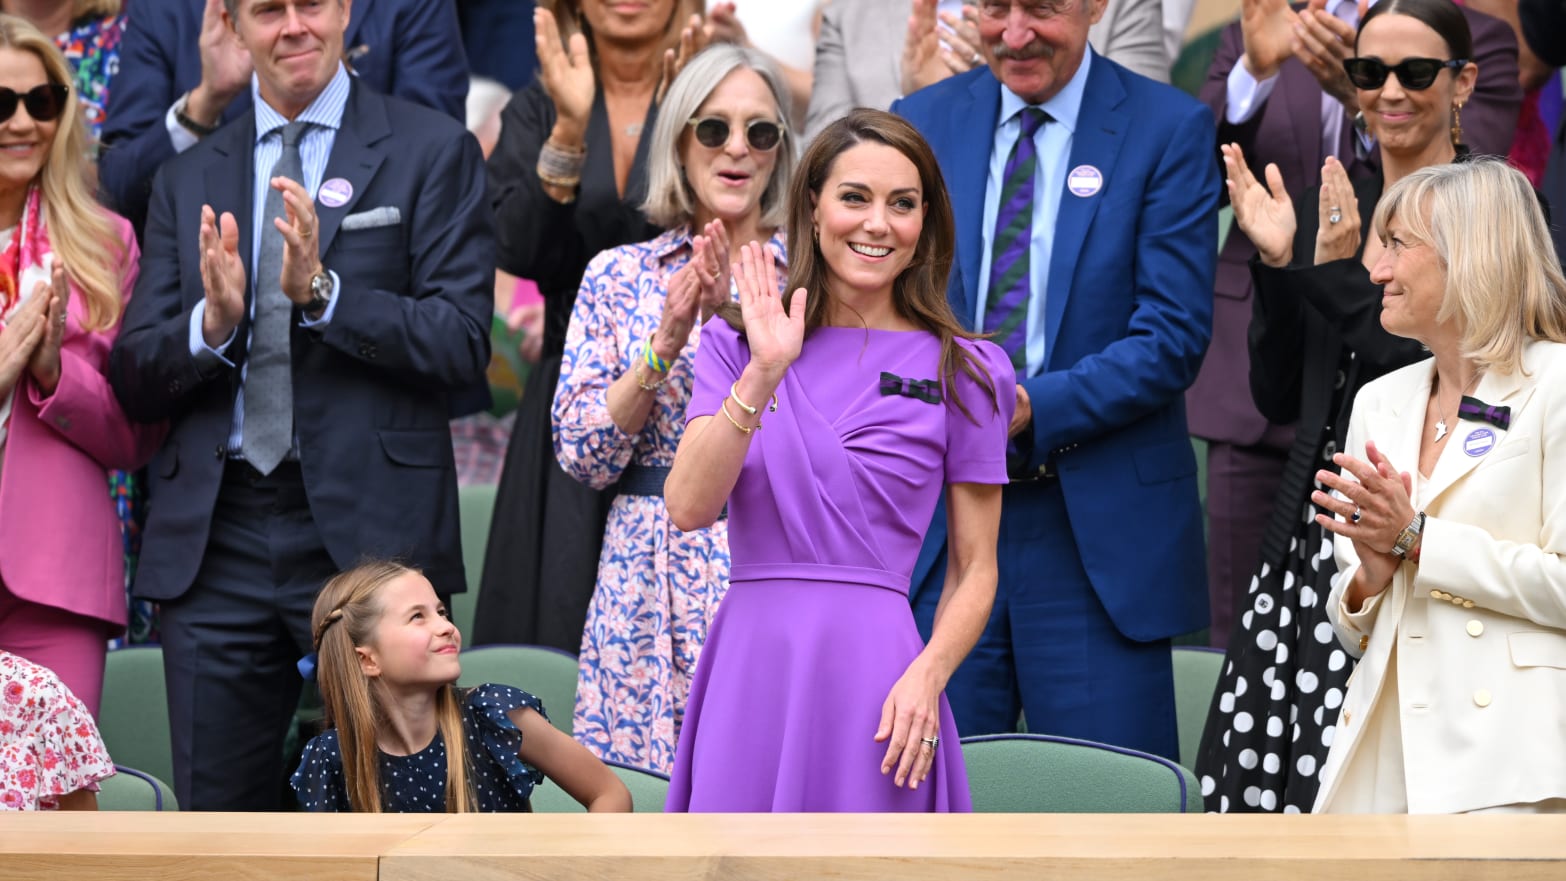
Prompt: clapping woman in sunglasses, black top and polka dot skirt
<box><xmin>1196</xmin><ymin>0</ymin><xmax>1478</xmax><ymax>812</ymax></box>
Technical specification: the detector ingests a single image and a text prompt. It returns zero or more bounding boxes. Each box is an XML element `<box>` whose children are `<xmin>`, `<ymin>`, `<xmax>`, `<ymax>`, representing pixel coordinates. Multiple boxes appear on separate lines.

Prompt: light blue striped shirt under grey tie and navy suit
<box><xmin>189</xmin><ymin>64</ymin><xmax>349</xmax><ymax>458</ymax></box>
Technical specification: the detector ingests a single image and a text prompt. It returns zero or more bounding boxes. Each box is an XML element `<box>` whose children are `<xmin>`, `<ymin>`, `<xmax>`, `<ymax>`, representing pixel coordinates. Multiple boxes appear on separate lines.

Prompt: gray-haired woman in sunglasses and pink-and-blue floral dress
<box><xmin>553</xmin><ymin>44</ymin><xmax>796</xmax><ymax>773</ymax></box>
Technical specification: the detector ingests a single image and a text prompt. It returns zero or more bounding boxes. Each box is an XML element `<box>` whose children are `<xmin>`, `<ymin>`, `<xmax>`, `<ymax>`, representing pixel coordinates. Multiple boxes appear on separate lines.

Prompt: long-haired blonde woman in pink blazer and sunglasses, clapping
<box><xmin>0</xmin><ymin>16</ymin><xmax>161</xmax><ymax>714</ymax></box>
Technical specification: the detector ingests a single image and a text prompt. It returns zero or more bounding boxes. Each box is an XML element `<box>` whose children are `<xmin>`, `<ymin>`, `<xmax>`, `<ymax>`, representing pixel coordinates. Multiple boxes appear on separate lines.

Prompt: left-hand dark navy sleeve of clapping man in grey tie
<box><xmin>108</xmin><ymin>172</ymin><xmax>234</xmax><ymax>423</ymax></box>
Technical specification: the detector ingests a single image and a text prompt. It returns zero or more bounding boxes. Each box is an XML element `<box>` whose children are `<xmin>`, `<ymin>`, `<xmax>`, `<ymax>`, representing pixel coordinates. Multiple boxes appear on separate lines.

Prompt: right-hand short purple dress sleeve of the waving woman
<box><xmin>946</xmin><ymin>340</ymin><xmax>1014</xmax><ymax>484</ymax></box>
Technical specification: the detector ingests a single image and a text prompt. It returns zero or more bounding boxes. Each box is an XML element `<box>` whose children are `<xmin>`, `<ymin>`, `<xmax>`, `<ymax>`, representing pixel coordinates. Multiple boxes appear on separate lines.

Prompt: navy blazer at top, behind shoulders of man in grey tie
<box><xmin>99</xmin><ymin>0</ymin><xmax>468</xmax><ymax>236</ymax></box>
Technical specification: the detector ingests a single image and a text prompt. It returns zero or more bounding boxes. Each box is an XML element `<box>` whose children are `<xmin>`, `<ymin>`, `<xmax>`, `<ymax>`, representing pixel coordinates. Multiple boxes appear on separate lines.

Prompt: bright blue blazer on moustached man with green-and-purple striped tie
<box><xmin>893</xmin><ymin>53</ymin><xmax>1220</xmax><ymax>640</ymax></box>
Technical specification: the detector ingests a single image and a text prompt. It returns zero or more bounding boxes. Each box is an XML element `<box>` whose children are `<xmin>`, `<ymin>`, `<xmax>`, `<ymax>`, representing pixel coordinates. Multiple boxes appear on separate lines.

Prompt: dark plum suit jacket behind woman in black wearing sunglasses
<box><xmin>1185</xmin><ymin>9</ymin><xmax>1522</xmax><ymax>446</ymax></box>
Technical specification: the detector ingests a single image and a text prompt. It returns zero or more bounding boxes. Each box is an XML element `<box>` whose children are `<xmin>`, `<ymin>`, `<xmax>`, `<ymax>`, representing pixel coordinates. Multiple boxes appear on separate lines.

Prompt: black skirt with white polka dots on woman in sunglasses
<box><xmin>1196</xmin><ymin>432</ymin><xmax>1353</xmax><ymax>814</ymax></box>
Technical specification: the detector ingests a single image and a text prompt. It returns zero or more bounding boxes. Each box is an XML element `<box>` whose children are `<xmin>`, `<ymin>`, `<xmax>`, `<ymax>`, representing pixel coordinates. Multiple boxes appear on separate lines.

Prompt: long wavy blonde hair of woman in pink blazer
<box><xmin>0</xmin><ymin>14</ymin><xmax>125</xmax><ymax>330</ymax></box>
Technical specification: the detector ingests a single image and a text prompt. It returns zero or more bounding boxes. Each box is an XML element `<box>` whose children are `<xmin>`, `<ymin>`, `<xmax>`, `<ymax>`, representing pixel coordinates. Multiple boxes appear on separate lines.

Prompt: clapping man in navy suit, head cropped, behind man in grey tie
<box><xmin>99</xmin><ymin>0</ymin><xmax>460</xmax><ymax>235</ymax></box>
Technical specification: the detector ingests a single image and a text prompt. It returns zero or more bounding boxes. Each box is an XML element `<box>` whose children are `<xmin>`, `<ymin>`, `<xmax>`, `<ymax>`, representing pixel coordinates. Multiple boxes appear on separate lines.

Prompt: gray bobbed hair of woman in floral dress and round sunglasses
<box><xmin>642</xmin><ymin>42</ymin><xmax>799</xmax><ymax>228</ymax></box>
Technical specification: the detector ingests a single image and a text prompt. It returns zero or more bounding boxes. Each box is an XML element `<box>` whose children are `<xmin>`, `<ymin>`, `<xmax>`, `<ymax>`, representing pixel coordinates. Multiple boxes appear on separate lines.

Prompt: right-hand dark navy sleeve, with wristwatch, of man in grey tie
<box><xmin>321</xmin><ymin>131</ymin><xmax>495</xmax><ymax>388</ymax></box>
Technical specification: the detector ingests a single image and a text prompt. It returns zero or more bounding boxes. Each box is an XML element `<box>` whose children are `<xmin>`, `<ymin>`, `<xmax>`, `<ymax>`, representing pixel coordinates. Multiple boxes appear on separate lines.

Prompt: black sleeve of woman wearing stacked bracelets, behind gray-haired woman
<box><xmin>489</xmin><ymin>83</ymin><xmax>592</xmax><ymax>289</ymax></box>
